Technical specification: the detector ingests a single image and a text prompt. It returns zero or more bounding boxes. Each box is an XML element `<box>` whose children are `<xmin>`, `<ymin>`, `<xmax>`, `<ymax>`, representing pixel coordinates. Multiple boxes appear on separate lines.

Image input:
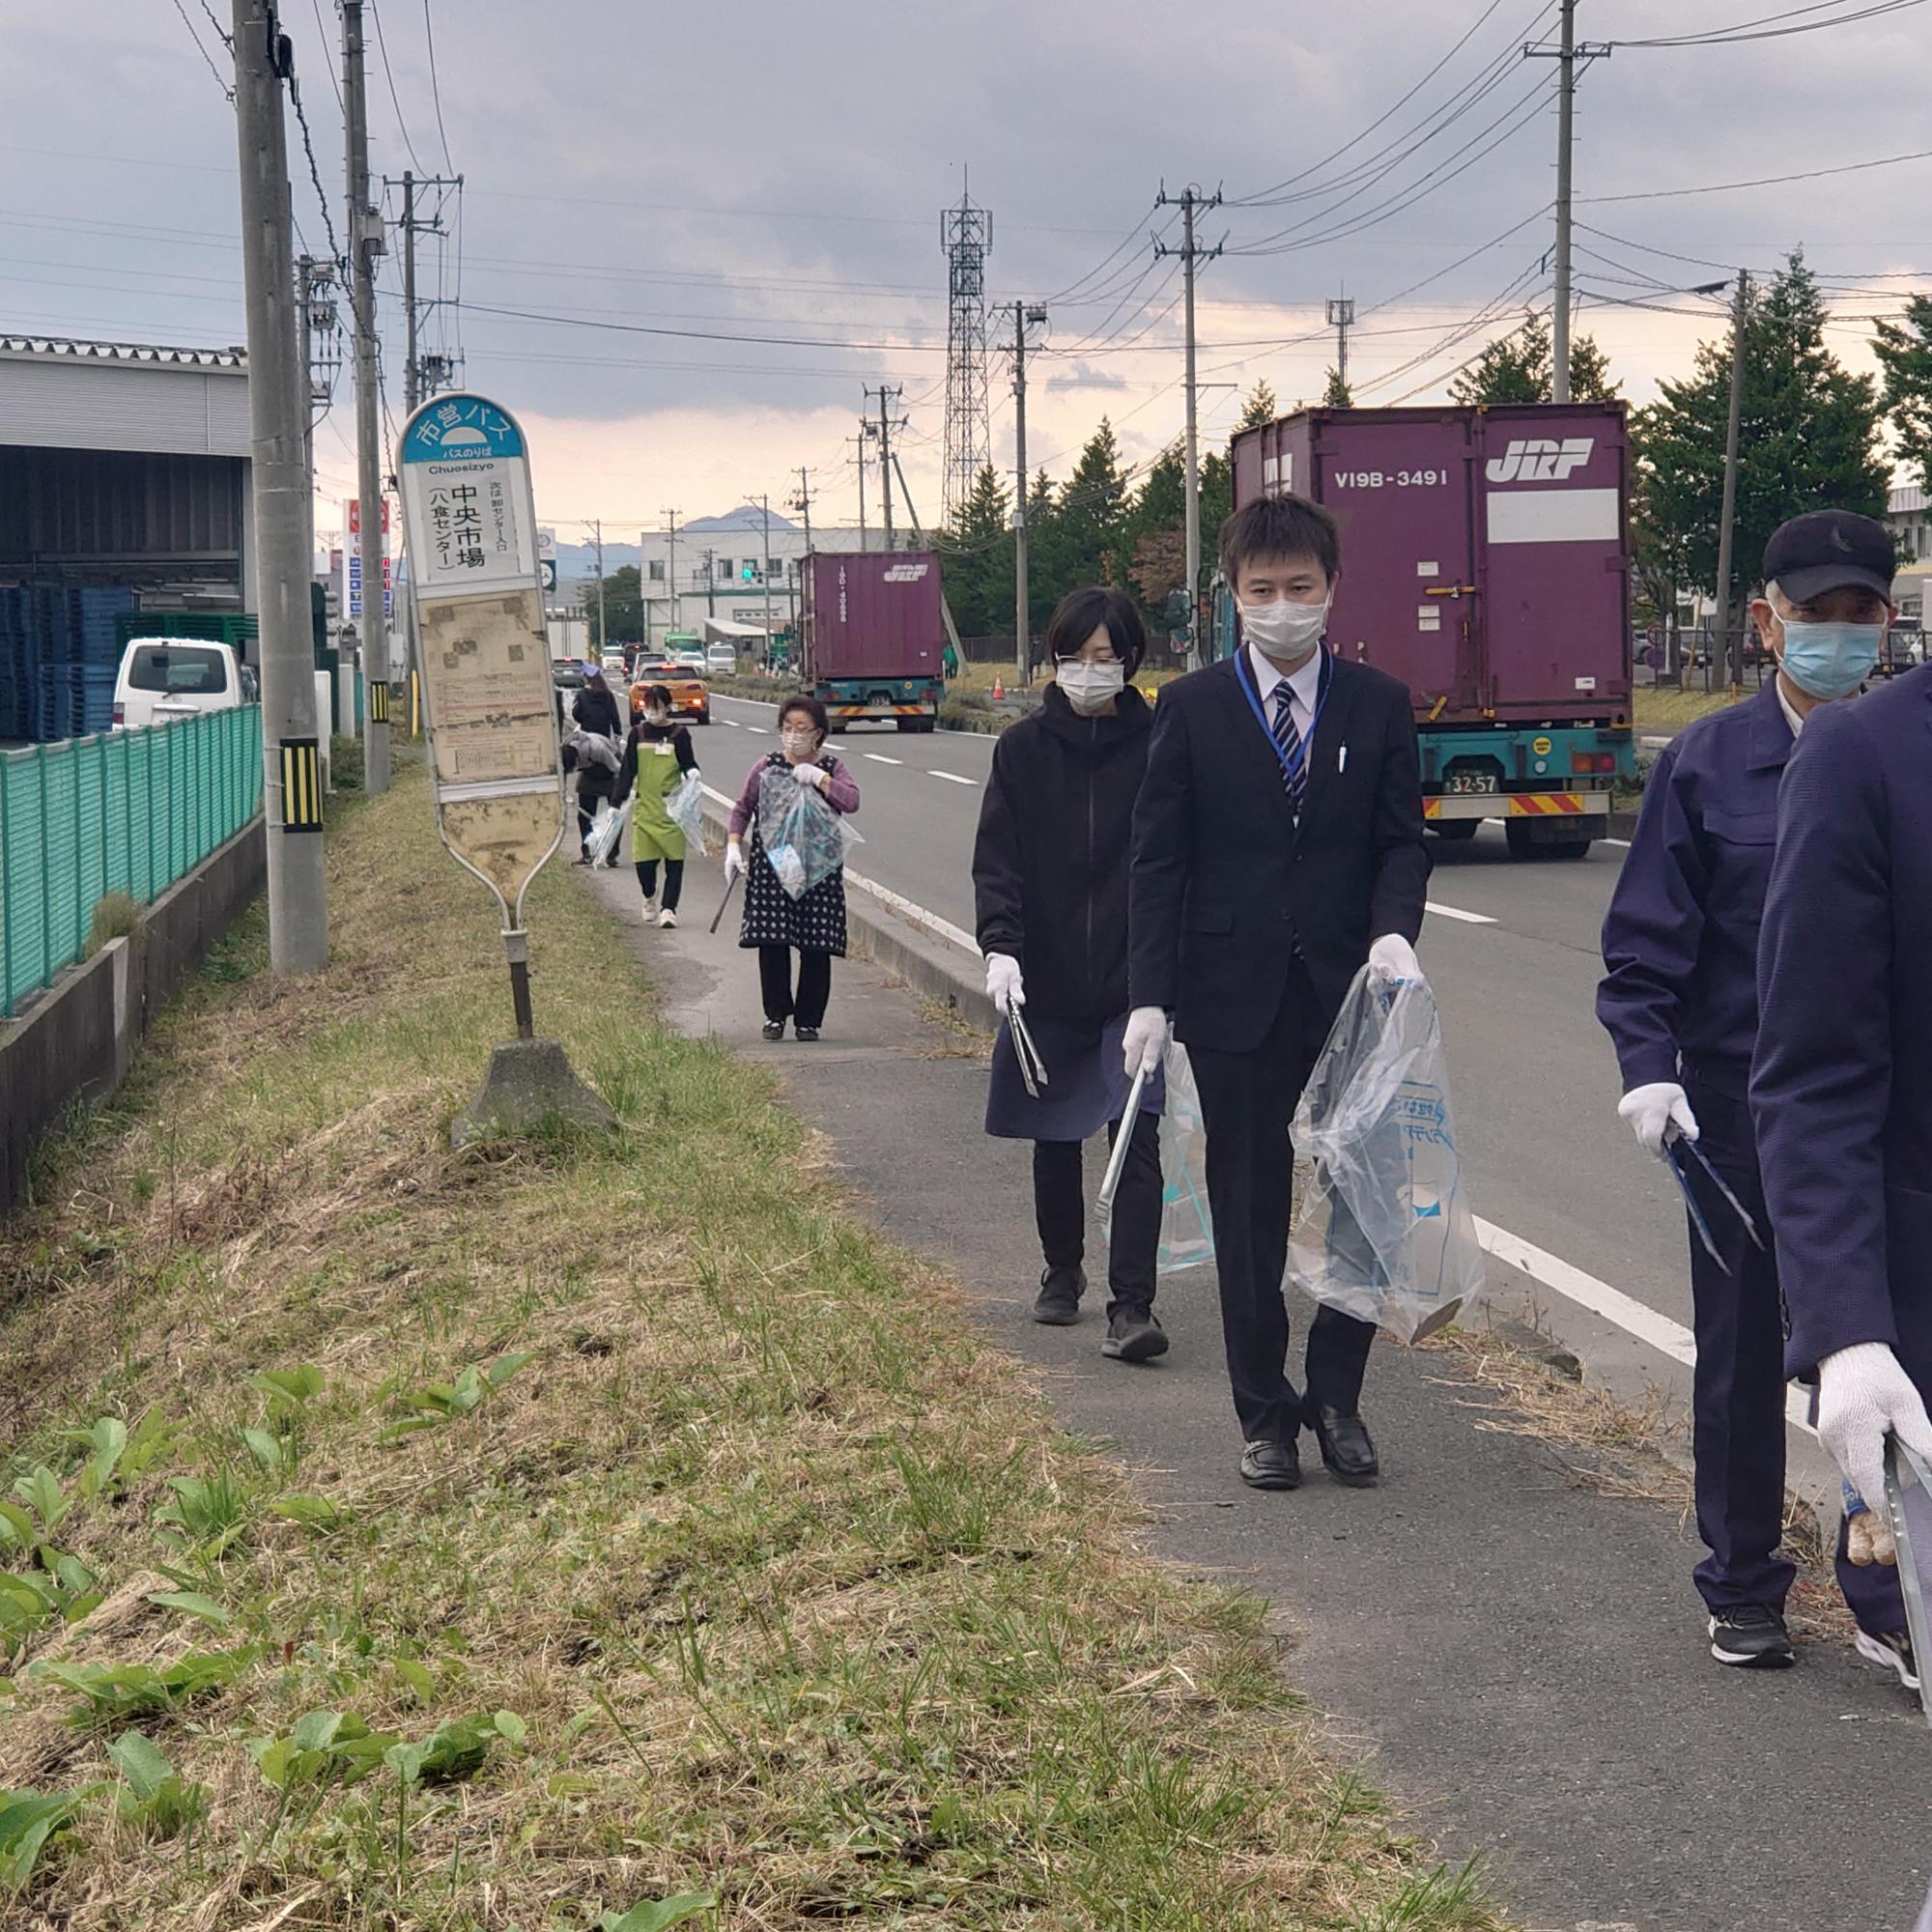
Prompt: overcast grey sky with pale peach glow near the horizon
<box><xmin>0</xmin><ymin>0</ymin><xmax>1932</xmax><ymax>539</ymax></box>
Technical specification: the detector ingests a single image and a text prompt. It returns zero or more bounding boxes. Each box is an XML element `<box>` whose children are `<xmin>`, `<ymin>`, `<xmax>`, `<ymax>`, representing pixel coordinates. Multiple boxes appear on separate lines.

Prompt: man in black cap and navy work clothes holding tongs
<box><xmin>1596</xmin><ymin>510</ymin><xmax>1905</xmax><ymax>1667</ymax></box>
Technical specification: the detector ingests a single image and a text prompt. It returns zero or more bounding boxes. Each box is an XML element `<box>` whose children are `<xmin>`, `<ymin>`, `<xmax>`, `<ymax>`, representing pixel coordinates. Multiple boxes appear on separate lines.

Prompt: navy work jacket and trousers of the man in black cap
<box><xmin>1596</xmin><ymin>680</ymin><xmax>1905</xmax><ymax>1633</ymax></box>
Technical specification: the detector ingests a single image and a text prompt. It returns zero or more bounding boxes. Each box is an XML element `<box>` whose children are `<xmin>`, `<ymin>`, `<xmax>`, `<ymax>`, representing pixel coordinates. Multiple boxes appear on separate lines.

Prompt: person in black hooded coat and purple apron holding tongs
<box><xmin>972</xmin><ymin>585</ymin><xmax>1167</xmax><ymax>1362</ymax></box>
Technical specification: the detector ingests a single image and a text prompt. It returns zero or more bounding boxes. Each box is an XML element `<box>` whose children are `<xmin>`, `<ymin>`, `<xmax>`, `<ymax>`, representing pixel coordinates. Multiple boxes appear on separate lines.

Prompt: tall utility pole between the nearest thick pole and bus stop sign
<box><xmin>342</xmin><ymin>0</ymin><xmax>388</xmax><ymax>794</ymax></box>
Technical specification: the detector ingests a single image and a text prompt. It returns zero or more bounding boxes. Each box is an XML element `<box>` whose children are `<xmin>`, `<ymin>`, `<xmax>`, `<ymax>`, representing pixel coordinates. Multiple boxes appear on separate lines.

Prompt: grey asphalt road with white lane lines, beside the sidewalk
<box><xmin>699</xmin><ymin>699</ymin><xmax>1770</xmax><ymax>1461</ymax></box>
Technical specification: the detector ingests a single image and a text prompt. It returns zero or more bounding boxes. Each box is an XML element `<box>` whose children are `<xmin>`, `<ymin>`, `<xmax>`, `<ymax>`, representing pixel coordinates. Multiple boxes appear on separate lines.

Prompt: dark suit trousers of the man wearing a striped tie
<box><xmin>1188</xmin><ymin>960</ymin><xmax>1376</xmax><ymax>1441</ymax></box>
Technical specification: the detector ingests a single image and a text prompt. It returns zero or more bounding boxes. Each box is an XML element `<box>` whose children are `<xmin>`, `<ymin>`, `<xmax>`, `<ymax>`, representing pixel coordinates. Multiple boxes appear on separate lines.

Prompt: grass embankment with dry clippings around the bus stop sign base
<box><xmin>0</xmin><ymin>763</ymin><xmax>1492</xmax><ymax>1932</ymax></box>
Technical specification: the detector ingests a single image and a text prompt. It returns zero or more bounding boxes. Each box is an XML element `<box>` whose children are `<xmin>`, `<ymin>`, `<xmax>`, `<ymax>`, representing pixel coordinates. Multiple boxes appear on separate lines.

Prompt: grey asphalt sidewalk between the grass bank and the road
<box><xmin>593</xmin><ymin>862</ymin><xmax>1932</xmax><ymax>1932</ymax></box>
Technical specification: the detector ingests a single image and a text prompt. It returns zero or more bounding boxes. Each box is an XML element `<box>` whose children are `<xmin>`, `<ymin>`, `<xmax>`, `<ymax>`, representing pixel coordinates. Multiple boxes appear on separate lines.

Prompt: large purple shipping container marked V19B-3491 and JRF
<box><xmin>1233</xmin><ymin>402</ymin><xmax>1631</xmax><ymax>726</ymax></box>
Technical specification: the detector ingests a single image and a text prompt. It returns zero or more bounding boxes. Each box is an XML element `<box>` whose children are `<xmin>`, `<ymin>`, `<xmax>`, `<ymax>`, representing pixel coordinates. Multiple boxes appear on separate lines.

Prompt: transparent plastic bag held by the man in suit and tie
<box><xmin>1289</xmin><ymin>966</ymin><xmax>1482</xmax><ymax>1341</ymax></box>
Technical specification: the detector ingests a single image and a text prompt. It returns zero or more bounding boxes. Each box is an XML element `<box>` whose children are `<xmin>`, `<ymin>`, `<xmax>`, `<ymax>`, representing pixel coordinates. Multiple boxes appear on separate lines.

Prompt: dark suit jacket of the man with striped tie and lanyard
<box><xmin>1128</xmin><ymin>657</ymin><xmax>1430</xmax><ymax>1053</ymax></box>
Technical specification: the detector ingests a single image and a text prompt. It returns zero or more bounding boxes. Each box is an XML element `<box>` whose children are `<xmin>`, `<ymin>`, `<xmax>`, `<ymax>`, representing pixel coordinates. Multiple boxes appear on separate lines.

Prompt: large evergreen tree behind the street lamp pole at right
<box><xmin>1636</xmin><ymin>253</ymin><xmax>1888</xmax><ymax>595</ymax></box>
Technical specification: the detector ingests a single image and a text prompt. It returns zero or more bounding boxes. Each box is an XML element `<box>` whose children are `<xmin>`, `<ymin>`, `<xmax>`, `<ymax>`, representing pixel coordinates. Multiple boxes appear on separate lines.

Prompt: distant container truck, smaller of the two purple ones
<box><xmin>798</xmin><ymin>551</ymin><xmax>947</xmax><ymax>732</ymax></box>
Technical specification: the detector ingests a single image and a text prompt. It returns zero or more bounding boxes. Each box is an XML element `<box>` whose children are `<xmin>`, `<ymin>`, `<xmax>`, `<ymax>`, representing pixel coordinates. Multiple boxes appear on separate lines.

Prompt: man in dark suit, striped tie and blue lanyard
<box><xmin>1126</xmin><ymin>497</ymin><xmax>1430</xmax><ymax>1490</ymax></box>
